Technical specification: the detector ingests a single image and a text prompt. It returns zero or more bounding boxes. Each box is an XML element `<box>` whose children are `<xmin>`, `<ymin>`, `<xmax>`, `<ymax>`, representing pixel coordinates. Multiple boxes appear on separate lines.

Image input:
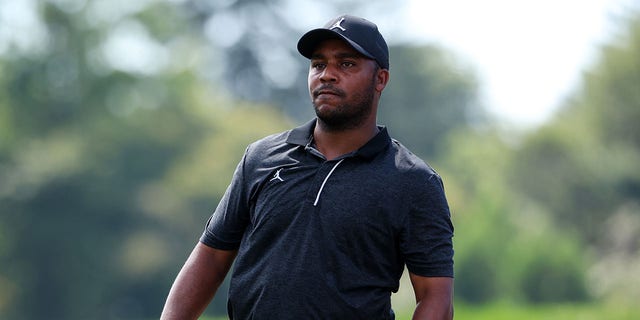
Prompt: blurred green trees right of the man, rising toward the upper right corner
<box><xmin>436</xmin><ymin>10</ymin><xmax>640</xmax><ymax>304</ymax></box>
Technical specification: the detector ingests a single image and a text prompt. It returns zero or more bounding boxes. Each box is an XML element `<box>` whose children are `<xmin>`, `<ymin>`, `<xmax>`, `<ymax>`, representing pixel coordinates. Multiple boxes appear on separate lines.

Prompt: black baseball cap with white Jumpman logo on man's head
<box><xmin>298</xmin><ymin>15</ymin><xmax>389</xmax><ymax>69</ymax></box>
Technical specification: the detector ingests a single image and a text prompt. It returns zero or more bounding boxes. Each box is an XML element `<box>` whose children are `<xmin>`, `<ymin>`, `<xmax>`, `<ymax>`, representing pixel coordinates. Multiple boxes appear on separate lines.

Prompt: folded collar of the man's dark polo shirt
<box><xmin>287</xmin><ymin>119</ymin><xmax>391</xmax><ymax>159</ymax></box>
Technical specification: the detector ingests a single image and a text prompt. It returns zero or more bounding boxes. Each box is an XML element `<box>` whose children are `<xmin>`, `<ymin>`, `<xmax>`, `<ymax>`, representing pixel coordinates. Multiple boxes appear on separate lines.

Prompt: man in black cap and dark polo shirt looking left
<box><xmin>162</xmin><ymin>16</ymin><xmax>453</xmax><ymax>320</ymax></box>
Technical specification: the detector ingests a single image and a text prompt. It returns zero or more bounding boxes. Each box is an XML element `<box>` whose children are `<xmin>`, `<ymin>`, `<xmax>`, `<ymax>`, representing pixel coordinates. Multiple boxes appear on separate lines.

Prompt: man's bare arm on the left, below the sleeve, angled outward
<box><xmin>160</xmin><ymin>243</ymin><xmax>237</xmax><ymax>320</ymax></box>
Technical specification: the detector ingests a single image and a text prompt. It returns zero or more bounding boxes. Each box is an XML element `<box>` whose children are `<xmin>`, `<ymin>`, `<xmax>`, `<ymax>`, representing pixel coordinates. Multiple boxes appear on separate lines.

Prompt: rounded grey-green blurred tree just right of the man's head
<box><xmin>378</xmin><ymin>46</ymin><xmax>481</xmax><ymax>158</ymax></box>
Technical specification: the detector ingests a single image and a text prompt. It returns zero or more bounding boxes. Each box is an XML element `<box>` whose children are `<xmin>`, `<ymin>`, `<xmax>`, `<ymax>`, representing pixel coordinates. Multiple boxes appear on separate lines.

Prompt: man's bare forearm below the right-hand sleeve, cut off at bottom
<box><xmin>409</xmin><ymin>272</ymin><xmax>453</xmax><ymax>320</ymax></box>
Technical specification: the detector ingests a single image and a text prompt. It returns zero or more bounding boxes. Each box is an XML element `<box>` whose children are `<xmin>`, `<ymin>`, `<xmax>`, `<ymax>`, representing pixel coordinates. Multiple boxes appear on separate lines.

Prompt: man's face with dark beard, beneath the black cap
<box><xmin>308</xmin><ymin>39</ymin><xmax>378</xmax><ymax>130</ymax></box>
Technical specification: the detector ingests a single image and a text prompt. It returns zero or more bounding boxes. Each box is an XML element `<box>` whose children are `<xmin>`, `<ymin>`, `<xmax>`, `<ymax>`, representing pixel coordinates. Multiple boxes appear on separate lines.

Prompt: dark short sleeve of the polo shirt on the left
<box><xmin>200</xmin><ymin>148</ymin><xmax>250</xmax><ymax>250</ymax></box>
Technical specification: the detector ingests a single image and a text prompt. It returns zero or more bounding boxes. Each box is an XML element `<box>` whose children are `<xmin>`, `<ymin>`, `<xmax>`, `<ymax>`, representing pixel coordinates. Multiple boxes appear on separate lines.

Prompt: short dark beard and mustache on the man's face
<box><xmin>313</xmin><ymin>81</ymin><xmax>375</xmax><ymax>131</ymax></box>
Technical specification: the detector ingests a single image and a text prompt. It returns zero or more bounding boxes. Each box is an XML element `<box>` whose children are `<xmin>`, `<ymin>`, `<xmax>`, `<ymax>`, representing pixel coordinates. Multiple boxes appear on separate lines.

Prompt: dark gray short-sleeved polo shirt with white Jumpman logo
<box><xmin>200</xmin><ymin>120</ymin><xmax>453</xmax><ymax>320</ymax></box>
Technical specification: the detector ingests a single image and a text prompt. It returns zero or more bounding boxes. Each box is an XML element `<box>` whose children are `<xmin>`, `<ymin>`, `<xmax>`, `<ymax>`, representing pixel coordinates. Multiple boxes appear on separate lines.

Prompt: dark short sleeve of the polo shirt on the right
<box><xmin>400</xmin><ymin>174</ymin><xmax>453</xmax><ymax>277</ymax></box>
